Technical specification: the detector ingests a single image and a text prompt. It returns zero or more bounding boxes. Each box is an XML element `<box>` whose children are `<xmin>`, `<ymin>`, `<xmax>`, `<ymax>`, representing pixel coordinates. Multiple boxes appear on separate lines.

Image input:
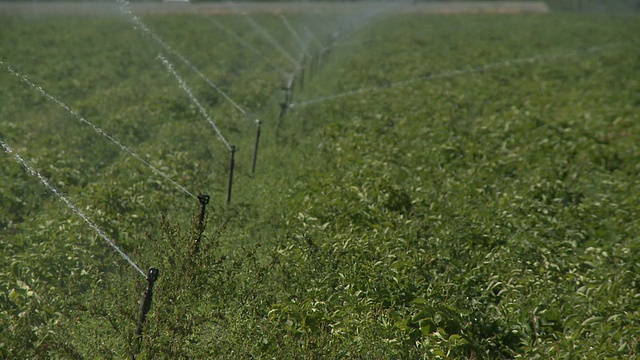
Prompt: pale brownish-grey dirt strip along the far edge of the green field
<box><xmin>0</xmin><ymin>1</ymin><xmax>549</xmax><ymax>15</ymax></box>
